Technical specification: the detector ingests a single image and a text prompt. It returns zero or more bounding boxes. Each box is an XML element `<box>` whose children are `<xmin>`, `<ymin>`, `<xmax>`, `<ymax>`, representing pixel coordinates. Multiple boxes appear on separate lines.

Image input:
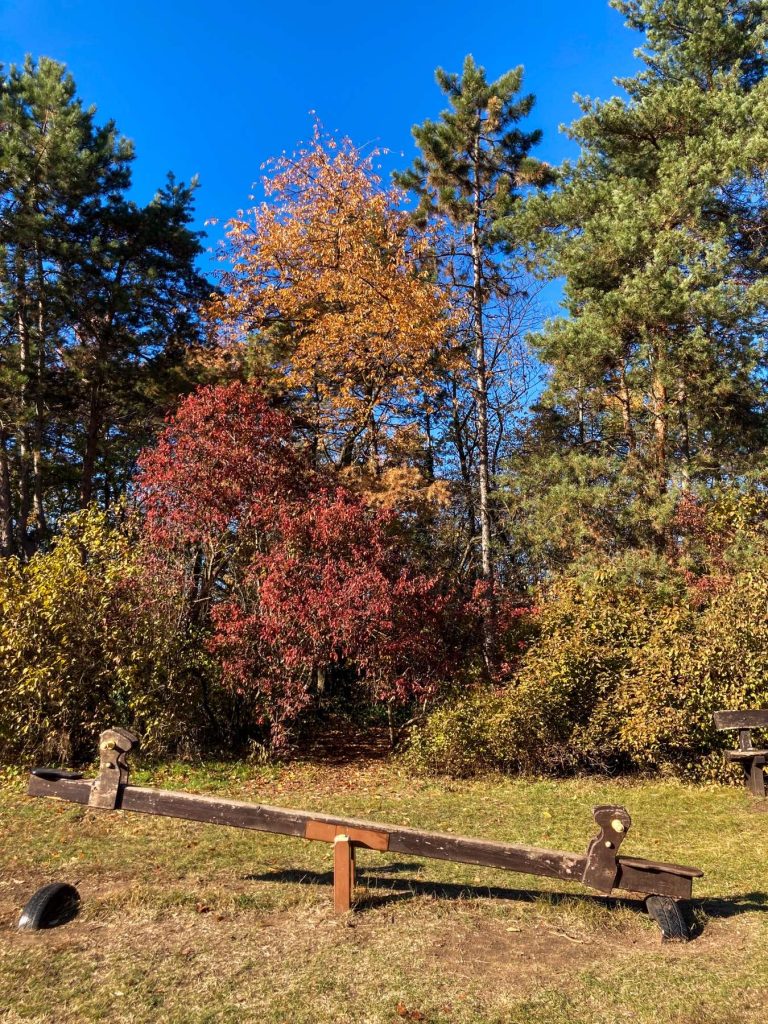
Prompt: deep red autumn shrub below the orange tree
<box><xmin>138</xmin><ymin>383</ymin><xmax>466</xmax><ymax>744</ymax></box>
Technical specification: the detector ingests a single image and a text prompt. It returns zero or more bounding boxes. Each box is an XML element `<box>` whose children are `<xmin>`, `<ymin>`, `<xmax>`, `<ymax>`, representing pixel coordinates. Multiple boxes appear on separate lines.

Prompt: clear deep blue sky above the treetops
<box><xmin>0</xmin><ymin>0</ymin><xmax>640</xmax><ymax>294</ymax></box>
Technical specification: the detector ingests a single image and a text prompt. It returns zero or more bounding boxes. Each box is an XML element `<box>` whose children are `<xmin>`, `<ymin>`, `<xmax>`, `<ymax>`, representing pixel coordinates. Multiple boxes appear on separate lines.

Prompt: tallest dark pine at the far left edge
<box><xmin>0</xmin><ymin>58</ymin><xmax>132</xmax><ymax>552</ymax></box>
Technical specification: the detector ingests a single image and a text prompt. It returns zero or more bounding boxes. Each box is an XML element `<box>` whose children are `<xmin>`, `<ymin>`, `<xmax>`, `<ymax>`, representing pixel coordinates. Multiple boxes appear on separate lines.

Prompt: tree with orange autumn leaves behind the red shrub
<box><xmin>211</xmin><ymin>127</ymin><xmax>460</xmax><ymax>477</ymax></box>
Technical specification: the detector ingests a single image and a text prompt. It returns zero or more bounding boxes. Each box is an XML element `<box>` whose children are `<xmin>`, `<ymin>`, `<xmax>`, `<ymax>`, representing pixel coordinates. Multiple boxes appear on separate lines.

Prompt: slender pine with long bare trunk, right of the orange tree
<box><xmin>395</xmin><ymin>56</ymin><xmax>548</xmax><ymax>583</ymax></box>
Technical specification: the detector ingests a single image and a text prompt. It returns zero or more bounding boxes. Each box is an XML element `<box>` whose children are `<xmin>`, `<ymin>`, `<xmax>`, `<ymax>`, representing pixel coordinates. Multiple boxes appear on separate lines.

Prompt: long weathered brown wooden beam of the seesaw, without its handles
<box><xmin>28</xmin><ymin>774</ymin><xmax>702</xmax><ymax>899</ymax></box>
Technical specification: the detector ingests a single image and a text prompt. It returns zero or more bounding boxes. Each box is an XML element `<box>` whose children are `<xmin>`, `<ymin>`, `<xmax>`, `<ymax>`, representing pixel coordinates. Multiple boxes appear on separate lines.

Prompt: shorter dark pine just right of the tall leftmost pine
<box><xmin>61</xmin><ymin>175</ymin><xmax>212</xmax><ymax>507</ymax></box>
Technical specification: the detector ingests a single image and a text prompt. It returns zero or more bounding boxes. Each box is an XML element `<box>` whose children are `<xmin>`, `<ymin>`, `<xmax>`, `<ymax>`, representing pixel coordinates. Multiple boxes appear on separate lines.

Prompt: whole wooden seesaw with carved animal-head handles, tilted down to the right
<box><xmin>28</xmin><ymin>729</ymin><xmax>702</xmax><ymax>940</ymax></box>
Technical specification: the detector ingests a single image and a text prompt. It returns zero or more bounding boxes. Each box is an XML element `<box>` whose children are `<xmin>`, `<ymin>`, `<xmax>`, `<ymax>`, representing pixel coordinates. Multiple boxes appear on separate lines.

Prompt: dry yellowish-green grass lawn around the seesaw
<box><xmin>0</xmin><ymin>762</ymin><xmax>768</xmax><ymax>1024</ymax></box>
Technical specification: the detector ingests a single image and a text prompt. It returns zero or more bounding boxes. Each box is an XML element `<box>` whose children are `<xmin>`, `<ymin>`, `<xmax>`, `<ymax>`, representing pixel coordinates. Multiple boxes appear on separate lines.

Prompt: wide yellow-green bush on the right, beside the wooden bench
<box><xmin>410</xmin><ymin>555</ymin><xmax>768</xmax><ymax>777</ymax></box>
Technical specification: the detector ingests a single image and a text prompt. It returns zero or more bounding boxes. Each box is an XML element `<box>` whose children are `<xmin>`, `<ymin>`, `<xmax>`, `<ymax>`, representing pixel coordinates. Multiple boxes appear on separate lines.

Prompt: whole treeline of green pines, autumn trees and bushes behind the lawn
<box><xmin>0</xmin><ymin>0</ymin><xmax>768</xmax><ymax>775</ymax></box>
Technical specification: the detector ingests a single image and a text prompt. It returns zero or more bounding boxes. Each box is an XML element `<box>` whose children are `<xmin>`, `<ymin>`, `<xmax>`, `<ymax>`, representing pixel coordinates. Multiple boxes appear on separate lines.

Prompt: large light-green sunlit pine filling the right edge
<box><xmin>513</xmin><ymin>0</ymin><xmax>768</xmax><ymax>565</ymax></box>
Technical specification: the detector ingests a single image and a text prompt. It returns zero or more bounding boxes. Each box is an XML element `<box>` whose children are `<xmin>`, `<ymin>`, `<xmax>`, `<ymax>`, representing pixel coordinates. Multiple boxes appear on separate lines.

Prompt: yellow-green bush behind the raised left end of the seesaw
<box><xmin>0</xmin><ymin>510</ymin><xmax>219</xmax><ymax>762</ymax></box>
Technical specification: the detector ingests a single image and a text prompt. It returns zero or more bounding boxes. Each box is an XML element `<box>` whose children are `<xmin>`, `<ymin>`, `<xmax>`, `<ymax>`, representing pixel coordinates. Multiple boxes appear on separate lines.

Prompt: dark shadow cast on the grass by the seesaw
<box><xmin>245</xmin><ymin>863</ymin><xmax>768</xmax><ymax>938</ymax></box>
